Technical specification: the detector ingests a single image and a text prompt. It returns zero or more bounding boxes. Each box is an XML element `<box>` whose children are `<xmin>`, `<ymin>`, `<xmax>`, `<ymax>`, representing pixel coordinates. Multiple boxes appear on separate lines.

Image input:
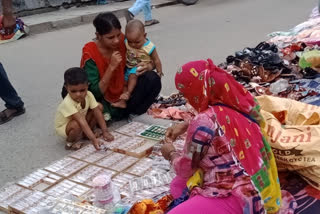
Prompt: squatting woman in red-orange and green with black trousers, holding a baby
<box><xmin>81</xmin><ymin>13</ymin><xmax>161</xmax><ymax>119</ymax></box>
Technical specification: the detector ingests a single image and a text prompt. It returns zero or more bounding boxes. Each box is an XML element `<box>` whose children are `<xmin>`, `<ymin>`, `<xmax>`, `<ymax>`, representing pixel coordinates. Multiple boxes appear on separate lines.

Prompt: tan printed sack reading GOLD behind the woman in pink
<box><xmin>257</xmin><ymin>96</ymin><xmax>320</xmax><ymax>189</ymax></box>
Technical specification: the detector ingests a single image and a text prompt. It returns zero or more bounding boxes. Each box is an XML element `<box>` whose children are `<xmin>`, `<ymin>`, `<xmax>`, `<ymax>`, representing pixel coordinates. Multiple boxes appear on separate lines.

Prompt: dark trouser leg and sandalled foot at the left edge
<box><xmin>0</xmin><ymin>63</ymin><xmax>25</xmax><ymax>124</ymax></box>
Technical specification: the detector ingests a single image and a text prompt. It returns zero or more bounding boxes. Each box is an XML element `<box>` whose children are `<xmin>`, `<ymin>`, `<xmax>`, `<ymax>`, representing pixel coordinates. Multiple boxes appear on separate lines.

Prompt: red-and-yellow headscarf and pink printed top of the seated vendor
<box><xmin>175</xmin><ymin>59</ymin><xmax>281</xmax><ymax>213</ymax></box>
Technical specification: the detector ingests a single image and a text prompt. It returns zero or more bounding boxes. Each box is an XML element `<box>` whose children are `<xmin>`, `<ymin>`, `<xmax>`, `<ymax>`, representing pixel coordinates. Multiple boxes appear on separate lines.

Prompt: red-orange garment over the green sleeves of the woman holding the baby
<box><xmin>81</xmin><ymin>35</ymin><xmax>126</xmax><ymax>103</ymax></box>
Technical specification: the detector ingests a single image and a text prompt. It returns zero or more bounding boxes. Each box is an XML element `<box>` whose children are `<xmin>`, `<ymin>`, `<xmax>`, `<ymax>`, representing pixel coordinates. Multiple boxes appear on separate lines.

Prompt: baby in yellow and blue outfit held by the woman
<box><xmin>112</xmin><ymin>19</ymin><xmax>163</xmax><ymax>108</ymax></box>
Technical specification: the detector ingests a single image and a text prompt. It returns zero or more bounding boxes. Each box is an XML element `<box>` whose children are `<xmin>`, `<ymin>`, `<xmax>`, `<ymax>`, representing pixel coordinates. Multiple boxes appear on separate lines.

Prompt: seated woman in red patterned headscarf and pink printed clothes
<box><xmin>162</xmin><ymin>59</ymin><xmax>292</xmax><ymax>214</ymax></box>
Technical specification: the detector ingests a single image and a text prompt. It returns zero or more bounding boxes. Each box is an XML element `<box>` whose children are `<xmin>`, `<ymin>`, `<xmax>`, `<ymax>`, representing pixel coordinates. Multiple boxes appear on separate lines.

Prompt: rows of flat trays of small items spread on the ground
<box><xmin>0</xmin><ymin>122</ymin><xmax>172</xmax><ymax>214</ymax></box>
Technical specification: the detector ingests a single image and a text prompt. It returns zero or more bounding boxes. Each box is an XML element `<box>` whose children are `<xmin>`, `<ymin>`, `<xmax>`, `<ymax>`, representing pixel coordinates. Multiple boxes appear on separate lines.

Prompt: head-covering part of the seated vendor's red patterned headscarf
<box><xmin>175</xmin><ymin>59</ymin><xmax>257</xmax><ymax>114</ymax></box>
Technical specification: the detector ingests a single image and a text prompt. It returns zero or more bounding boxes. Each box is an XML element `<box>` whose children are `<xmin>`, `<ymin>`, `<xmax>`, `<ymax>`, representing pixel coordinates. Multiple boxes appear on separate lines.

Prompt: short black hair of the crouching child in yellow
<box><xmin>64</xmin><ymin>67</ymin><xmax>88</xmax><ymax>85</ymax></box>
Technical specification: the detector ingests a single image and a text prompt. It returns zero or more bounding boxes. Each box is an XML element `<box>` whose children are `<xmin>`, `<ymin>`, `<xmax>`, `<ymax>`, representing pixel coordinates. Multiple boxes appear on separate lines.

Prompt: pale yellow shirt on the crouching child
<box><xmin>54</xmin><ymin>91</ymin><xmax>98</xmax><ymax>138</ymax></box>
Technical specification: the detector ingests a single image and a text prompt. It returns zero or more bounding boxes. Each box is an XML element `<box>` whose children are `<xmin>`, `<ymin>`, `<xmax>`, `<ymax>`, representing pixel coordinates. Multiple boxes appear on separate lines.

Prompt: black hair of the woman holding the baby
<box><xmin>93</xmin><ymin>12</ymin><xmax>121</xmax><ymax>35</ymax></box>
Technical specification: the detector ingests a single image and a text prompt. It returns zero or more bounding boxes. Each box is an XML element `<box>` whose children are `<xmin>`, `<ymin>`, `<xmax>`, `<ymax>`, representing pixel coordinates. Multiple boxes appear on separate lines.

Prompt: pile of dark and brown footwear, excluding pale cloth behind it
<box><xmin>220</xmin><ymin>42</ymin><xmax>320</xmax><ymax>104</ymax></box>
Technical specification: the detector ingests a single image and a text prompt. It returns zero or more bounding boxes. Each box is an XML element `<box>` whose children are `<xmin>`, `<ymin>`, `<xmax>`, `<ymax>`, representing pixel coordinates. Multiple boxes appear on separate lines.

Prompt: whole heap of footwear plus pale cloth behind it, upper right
<box><xmin>220</xmin><ymin>9</ymin><xmax>320</xmax><ymax>105</ymax></box>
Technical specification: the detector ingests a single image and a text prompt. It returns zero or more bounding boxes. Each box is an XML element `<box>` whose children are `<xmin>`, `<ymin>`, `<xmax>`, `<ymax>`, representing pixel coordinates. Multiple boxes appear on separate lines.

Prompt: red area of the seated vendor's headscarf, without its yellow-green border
<box><xmin>175</xmin><ymin>59</ymin><xmax>263</xmax><ymax>175</ymax></box>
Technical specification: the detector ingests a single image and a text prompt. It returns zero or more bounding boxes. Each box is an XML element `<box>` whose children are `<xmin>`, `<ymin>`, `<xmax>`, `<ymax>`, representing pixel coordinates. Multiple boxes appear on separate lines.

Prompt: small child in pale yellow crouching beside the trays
<box><xmin>55</xmin><ymin>68</ymin><xmax>114</xmax><ymax>150</ymax></box>
